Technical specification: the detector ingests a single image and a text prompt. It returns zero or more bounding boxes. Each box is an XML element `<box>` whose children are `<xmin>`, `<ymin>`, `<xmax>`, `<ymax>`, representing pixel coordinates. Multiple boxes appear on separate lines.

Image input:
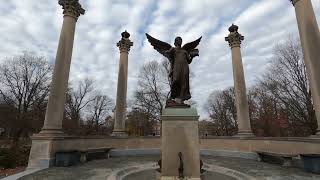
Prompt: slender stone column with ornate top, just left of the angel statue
<box><xmin>112</xmin><ymin>31</ymin><xmax>133</xmax><ymax>137</ymax></box>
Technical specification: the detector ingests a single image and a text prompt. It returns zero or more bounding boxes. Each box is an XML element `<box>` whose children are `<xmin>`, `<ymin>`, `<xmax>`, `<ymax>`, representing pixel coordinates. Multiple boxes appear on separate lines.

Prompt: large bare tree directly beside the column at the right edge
<box><xmin>261</xmin><ymin>39</ymin><xmax>317</xmax><ymax>135</ymax></box>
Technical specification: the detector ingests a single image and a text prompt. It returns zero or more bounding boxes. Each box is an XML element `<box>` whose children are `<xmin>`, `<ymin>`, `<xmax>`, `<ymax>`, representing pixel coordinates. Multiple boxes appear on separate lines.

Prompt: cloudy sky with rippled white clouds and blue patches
<box><xmin>0</xmin><ymin>0</ymin><xmax>320</xmax><ymax>117</ymax></box>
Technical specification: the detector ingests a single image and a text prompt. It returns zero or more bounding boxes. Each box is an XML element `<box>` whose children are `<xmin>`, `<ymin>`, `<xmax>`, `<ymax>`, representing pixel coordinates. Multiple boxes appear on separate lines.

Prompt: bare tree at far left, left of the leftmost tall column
<box><xmin>0</xmin><ymin>52</ymin><xmax>52</xmax><ymax>138</ymax></box>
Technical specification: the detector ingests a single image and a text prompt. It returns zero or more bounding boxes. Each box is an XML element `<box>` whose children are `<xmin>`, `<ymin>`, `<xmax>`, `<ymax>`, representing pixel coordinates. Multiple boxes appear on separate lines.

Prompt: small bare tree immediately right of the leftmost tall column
<box><xmin>66</xmin><ymin>79</ymin><xmax>94</xmax><ymax>129</ymax></box>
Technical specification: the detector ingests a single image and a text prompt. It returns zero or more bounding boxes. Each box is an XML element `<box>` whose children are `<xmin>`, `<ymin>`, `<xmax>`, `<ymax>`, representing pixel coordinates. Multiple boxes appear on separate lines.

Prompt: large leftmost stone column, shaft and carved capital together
<box><xmin>40</xmin><ymin>0</ymin><xmax>85</xmax><ymax>135</ymax></box>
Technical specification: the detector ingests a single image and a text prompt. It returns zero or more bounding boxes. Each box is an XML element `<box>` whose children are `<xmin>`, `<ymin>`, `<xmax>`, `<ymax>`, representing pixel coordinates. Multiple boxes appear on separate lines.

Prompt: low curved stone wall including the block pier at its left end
<box><xmin>28</xmin><ymin>137</ymin><xmax>320</xmax><ymax>168</ymax></box>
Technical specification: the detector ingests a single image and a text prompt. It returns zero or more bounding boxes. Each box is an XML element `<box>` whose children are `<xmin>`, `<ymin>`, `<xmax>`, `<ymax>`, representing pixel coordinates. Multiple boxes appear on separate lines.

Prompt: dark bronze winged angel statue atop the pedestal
<box><xmin>146</xmin><ymin>33</ymin><xmax>202</xmax><ymax>107</ymax></box>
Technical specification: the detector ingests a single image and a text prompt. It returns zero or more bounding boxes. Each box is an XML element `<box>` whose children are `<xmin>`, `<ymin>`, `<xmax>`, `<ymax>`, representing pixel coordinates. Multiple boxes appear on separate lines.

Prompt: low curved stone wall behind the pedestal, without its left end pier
<box><xmin>53</xmin><ymin>137</ymin><xmax>320</xmax><ymax>154</ymax></box>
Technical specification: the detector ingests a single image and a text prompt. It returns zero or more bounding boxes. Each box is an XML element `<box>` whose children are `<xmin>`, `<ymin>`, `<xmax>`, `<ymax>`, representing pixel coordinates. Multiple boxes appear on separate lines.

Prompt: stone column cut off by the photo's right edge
<box><xmin>290</xmin><ymin>0</ymin><xmax>320</xmax><ymax>137</ymax></box>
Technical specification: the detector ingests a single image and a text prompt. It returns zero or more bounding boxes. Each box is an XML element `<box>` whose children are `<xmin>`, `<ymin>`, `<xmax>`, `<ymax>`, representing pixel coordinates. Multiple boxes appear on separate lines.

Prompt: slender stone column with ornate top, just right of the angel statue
<box><xmin>225</xmin><ymin>24</ymin><xmax>252</xmax><ymax>136</ymax></box>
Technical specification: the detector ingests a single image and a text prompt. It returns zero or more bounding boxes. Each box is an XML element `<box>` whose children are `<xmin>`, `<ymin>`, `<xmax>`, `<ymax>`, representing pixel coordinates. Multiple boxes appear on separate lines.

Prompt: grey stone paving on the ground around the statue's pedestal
<box><xmin>20</xmin><ymin>157</ymin><xmax>320</xmax><ymax>180</ymax></box>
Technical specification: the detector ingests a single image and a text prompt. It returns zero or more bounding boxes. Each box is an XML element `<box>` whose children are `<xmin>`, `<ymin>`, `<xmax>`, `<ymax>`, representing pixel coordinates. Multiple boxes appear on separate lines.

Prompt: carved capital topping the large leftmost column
<box><xmin>59</xmin><ymin>0</ymin><xmax>85</xmax><ymax>19</ymax></box>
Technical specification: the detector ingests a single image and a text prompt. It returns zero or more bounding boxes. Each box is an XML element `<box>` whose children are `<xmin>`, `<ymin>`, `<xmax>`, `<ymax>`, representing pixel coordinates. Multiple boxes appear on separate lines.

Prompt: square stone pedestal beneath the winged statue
<box><xmin>161</xmin><ymin>108</ymin><xmax>200</xmax><ymax>180</ymax></box>
